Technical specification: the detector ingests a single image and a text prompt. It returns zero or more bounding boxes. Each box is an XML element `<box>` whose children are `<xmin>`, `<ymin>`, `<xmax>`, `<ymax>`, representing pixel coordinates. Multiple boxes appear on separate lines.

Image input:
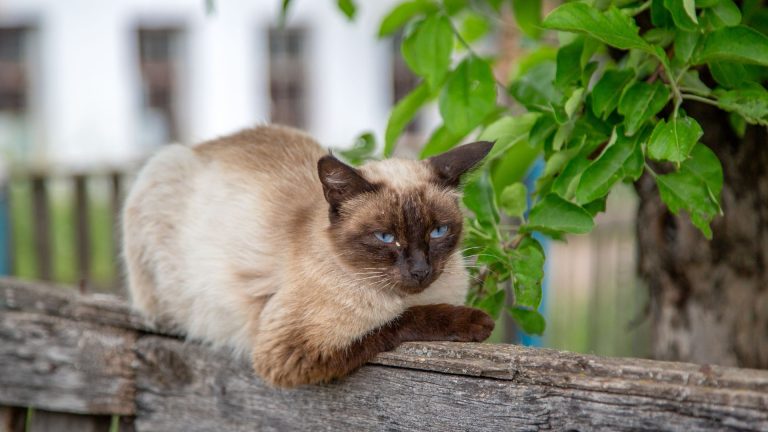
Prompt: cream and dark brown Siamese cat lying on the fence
<box><xmin>122</xmin><ymin>126</ymin><xmax>494</xmax><ymax>387</ymax></box>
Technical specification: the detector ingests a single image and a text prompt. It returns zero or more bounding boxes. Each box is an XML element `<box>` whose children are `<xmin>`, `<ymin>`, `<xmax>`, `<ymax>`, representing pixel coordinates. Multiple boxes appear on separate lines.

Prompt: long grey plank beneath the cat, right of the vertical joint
<box><xmin>136</xmin><ymin>336</ymin><xmax>768</xmax><ymax>431</ymax></box>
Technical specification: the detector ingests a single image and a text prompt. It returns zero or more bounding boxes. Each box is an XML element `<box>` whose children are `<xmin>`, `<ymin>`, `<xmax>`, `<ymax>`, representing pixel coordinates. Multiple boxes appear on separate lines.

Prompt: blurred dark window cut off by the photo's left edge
<box><xmin>0</xmin><ymin>27</ymin><xmax>29</xmax><ymax>113</ymax></box>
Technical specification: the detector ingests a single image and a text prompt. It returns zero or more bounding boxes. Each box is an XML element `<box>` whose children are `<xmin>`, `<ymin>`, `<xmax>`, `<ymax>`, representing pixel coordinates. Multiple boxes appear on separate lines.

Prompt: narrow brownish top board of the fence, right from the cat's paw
<box><xmin>374</xmin><ymin>342</ymin><xmax>768</xmax><ymax>413</ymax></box>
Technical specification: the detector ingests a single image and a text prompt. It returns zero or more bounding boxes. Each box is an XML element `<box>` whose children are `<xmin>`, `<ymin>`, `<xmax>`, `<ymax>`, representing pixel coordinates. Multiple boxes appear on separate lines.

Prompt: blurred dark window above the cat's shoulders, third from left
<box><xmin>269</xmin><ymin>28</ymin><xmax>307</xmax><ymax>127</ymax></box>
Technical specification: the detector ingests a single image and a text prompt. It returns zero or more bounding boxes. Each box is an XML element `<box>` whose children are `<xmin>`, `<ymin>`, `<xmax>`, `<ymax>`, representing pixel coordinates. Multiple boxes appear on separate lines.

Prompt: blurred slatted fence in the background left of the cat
<box><xmin>0</xmin><ymin>170</ymin><xmax>129</xmax><ymax>292</ymax></box>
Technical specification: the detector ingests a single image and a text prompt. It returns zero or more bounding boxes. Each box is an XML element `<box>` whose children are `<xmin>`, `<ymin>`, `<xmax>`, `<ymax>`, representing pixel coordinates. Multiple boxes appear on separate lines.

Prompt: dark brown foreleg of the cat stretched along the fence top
<box><xmin>253</xmin><ymin>304</ymin><xmax>494</xmax><ymax>387</ymax></box>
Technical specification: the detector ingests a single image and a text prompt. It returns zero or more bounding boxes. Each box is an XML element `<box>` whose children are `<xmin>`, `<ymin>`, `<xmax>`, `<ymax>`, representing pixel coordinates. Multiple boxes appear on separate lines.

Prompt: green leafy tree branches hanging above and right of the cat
<box><xmin>283</xmin><ymin>0</ymin><xmax>768</xmax><ymax>334</ymax></box>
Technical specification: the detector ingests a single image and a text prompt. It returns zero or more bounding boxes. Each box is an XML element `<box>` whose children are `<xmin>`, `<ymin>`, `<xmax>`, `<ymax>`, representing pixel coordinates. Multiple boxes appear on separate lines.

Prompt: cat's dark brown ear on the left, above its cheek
<box><xmin>317</xmin><ymin>155</ymin><xmax>376</xmax><ymax>211</ymax></box>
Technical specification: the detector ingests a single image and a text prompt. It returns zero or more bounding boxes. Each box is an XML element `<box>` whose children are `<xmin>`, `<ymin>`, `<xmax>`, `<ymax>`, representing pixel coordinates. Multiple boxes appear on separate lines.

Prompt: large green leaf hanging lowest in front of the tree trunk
<box><xmin>656</xmin><ymin>144</ymin><xmax>723</xmax><ymax>239</ymax></box>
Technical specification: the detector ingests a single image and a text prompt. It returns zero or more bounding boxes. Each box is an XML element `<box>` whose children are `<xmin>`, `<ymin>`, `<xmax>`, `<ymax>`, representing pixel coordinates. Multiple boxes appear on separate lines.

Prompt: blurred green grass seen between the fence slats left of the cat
<box><xmin>10</xmin><ymin>177</ymin><xmax>117</xmax><ymax>290</ymax></box>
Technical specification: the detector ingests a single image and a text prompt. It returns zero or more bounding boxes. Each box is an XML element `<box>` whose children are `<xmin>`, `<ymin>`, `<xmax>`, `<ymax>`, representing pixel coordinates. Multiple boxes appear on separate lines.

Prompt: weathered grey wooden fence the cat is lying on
<box><xmin>0</xmin><ymin>279</ymin><xmax>768</xmax><ymax>431</ymax></box>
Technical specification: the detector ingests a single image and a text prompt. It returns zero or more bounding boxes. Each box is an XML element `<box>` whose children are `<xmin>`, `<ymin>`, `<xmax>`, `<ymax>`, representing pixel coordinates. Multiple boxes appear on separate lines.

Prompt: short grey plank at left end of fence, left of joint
<box><xmin>0</xmin><ymin>311</ymin><xmax>136</xmax><ymax>414</ymax></box>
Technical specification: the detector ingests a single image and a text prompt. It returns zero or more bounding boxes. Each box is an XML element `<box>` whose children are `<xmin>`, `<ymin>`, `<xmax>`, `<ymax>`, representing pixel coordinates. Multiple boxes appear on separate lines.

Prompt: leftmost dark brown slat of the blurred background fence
<box><xmin>30</xmin><ymin>175</ymin><xmax>53</xmax><ymax>280</ymax></box>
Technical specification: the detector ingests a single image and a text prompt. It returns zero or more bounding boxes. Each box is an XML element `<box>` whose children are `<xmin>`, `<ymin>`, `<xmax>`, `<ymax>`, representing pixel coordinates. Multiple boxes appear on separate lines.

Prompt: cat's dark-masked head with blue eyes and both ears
<box><xmin>318</xmin><ymin>141</ymin><xmax>493</xmax><ymax>294</ymax></box>
